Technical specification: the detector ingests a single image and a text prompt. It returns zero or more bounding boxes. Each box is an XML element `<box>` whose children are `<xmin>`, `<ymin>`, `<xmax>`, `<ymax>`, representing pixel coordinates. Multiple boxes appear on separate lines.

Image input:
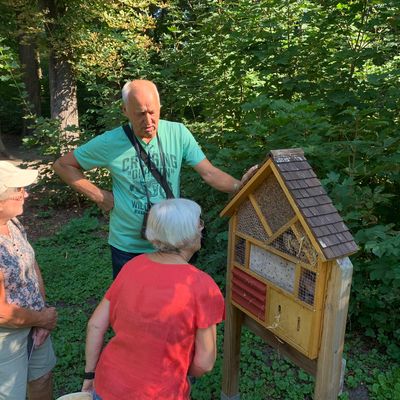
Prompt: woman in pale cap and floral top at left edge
<box><xmin>0</xmin><ymin>161</ymin><xmax>57</xmax><ymax>400</ymax></box>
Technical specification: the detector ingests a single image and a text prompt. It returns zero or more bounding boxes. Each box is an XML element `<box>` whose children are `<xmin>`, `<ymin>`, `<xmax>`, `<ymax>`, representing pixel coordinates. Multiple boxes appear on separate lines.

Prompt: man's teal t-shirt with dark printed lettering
<box><xmin>74</xmin><ymin>120</ymin><xmax>206</xmax><ymax>253</ymax></box>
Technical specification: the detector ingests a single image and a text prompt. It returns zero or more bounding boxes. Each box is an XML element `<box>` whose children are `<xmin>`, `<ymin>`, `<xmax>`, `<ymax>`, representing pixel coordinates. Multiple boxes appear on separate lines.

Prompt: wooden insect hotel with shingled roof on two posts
<box><xmin>221</xmin><ymin>149</ymin><xmax>358</xmax><ymax>400</ymax></box>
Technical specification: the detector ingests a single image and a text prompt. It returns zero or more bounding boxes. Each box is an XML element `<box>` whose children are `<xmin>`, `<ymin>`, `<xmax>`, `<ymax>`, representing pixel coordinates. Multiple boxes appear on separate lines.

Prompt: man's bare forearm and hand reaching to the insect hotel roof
<box><xmin>193</xmin><ymin>158</ymin><xmax>258</xmax><ymax>193</ymax></box>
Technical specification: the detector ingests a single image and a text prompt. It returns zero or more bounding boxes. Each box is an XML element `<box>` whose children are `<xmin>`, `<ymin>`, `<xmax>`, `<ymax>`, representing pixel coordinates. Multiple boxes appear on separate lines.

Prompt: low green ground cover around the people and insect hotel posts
<box><xmin>34</xmin><ymin>215</ymin><xmax>400</xmax><ymax>400</ymax></box>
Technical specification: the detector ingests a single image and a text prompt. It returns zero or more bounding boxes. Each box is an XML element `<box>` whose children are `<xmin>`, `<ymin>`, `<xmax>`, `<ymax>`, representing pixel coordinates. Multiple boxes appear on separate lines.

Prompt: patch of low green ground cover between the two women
<box><xmin>34</xmin><ymin>214</ymin><xmax>111</xmax><ymax>397</ymax></box>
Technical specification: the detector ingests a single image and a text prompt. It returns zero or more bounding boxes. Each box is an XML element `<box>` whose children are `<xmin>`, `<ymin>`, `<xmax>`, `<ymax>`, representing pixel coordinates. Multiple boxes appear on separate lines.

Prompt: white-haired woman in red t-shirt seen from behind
<box><xmin>82</xmin><ymin>199</ymin><xmax>224</xmax><ymax>400</ymax></box>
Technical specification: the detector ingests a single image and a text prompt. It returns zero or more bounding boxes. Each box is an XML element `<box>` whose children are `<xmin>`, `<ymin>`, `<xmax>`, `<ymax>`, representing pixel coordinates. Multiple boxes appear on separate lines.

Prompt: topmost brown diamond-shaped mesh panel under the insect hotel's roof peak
<box><xmin>253</xmin><ymin>174</ymin><xmax>295</xmax><ymax>232</ymax></box>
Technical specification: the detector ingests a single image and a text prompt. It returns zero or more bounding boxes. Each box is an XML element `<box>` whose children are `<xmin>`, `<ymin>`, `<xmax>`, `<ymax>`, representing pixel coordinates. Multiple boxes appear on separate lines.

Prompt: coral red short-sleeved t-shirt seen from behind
<box><xmin>95</xmin><ymin>255</ymin><xmax>224</xmax><ymax>400</ymax></box>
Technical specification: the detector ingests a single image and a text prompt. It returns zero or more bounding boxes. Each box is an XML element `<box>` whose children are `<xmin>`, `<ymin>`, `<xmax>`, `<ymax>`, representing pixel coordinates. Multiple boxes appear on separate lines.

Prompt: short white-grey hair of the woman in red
<box><xmin>146</xmin><ymin>199</ymin><xmax>201</xmax><ymax>253</ymax></box>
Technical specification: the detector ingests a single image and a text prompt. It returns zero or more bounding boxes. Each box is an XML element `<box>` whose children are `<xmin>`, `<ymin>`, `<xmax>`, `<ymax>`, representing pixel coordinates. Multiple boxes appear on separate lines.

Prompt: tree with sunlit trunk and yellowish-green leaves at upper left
<box><xmin>1</xmin><ymin>0</ymin><xmax>161</xmax><ymax>153</ymax></box>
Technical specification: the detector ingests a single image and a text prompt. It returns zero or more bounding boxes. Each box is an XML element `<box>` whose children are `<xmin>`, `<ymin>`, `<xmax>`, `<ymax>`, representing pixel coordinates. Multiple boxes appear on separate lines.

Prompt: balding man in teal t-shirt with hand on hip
<box><xmin>53</xmin><ymin>80</ymin><xmax>253</xmax><ymax>278</ymax></box>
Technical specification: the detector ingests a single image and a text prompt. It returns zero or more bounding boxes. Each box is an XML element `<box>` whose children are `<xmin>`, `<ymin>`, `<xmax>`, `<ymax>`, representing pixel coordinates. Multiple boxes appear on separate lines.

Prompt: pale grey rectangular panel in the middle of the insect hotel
<box><xmin>249</xmin><ymin>245</ymin><xmax>296</xmax><ymax>293</ymax></box>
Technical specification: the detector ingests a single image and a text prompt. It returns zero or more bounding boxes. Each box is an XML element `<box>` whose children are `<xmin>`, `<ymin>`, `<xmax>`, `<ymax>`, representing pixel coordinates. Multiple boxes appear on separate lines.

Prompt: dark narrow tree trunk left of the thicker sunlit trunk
<box><xmin>19</xmin><ymin>35</ymin><xmax>41</xmax><ymax>135</ymax></box>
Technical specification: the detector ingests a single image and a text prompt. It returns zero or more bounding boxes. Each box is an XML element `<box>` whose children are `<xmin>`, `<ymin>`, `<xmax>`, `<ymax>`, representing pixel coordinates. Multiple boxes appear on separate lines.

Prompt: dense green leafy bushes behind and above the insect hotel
<box><xmin>160</xmin><ymin>1</ymin><xmax>400</xmax><ymax>358</ymax></box>
